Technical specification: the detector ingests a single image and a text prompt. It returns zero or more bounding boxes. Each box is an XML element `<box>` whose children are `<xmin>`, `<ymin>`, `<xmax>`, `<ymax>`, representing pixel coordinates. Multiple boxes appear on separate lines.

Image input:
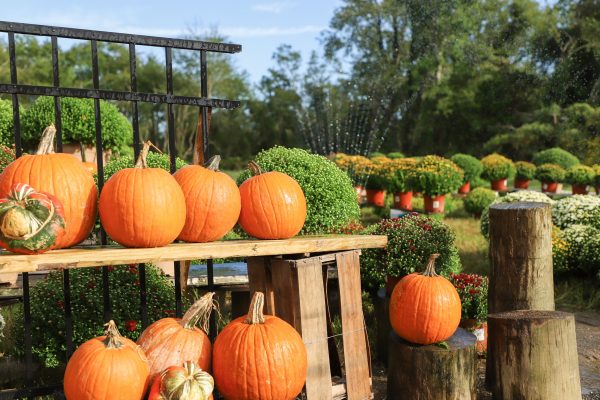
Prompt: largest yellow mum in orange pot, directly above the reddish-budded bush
<box><xmin>408</xmin><ymin>155</ymin><xmax>464</xmax><ymax>213</ymax></box>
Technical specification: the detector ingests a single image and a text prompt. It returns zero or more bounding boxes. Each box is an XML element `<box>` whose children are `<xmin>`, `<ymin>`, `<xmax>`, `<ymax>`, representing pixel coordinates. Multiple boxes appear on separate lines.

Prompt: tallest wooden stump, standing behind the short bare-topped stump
<box><xmin>488</xmin><ymin>202</ymin><xmax>554</xmax><ymax>313</ymax></box>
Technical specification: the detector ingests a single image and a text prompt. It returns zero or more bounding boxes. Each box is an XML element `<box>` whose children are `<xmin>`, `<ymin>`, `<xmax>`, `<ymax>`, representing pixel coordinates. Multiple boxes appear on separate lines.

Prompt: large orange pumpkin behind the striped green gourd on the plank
<box><xmin>0</xmin><ymin>125</ymin><xmax>98</xmax><ymax>248</ymax></box>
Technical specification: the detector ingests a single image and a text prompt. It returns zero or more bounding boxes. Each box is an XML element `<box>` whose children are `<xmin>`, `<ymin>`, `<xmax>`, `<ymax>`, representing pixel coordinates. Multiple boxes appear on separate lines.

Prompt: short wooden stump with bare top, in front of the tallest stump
<box><xmin>486</xmin><ymin>311</ymin><xmax>581</xmax><ymax>400</ymax></box>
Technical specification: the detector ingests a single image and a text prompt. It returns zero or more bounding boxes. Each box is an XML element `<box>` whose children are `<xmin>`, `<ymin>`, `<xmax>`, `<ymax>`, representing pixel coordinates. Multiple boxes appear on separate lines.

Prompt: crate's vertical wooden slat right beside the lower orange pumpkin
<box><xmin>296</xmin><ymin>257</ymin><xmax>332</xmax><ymax>400</ymax></box>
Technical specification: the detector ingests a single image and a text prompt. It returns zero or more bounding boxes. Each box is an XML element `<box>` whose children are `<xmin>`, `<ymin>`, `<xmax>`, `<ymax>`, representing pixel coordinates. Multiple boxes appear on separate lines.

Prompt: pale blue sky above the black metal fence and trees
<box><xmin>0</xmin><ymin>0</ymin><xmax>342</xmax><ymax>82</ymax></box>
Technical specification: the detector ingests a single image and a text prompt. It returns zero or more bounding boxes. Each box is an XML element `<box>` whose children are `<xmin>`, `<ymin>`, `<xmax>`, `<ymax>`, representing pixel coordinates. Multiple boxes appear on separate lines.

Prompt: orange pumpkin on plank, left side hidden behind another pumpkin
<box><xmin>173</xmin><ymin>156</ymin><xmax>240</xmax><ymax>242</ymax></box>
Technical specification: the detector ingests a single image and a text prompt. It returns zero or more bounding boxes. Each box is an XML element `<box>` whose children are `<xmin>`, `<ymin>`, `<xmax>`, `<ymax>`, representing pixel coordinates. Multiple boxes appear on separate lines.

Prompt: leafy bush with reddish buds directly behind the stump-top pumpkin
<box><xmin>360</xmin><ymin>213</ymin><xmax>461</xmax><ymax>291</ymax></box>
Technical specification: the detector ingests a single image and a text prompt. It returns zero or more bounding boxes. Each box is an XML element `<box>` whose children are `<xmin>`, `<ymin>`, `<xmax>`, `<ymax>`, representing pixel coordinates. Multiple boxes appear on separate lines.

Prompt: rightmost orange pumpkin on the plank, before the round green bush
<box><xmin>239</xmin><ymin>162</ymin><xmax>306</xmax><ymax>239</ymax></box>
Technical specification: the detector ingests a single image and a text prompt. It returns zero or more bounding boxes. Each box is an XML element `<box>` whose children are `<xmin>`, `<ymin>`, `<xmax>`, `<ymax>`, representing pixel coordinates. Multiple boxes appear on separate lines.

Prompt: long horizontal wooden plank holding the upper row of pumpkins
<box><xmin>0</xmin><ymin>235</ymin><xmax>387</xmax><ymax>274</ymax></box>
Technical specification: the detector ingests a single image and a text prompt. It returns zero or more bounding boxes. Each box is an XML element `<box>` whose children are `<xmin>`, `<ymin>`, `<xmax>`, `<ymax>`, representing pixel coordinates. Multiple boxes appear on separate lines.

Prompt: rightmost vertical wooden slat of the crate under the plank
<box><xmin>336</xmin><ymin>251</ymin><xmax>371</xmax><ymax>400</ymax></box>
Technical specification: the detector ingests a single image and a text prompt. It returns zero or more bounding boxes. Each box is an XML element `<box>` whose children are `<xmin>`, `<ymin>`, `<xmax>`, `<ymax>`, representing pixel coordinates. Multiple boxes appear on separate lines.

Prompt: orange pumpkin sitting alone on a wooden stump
<box><xmin>390</xmin><ymin>254</ymin><xmax>461</xmax><ymax>344</ymax></box>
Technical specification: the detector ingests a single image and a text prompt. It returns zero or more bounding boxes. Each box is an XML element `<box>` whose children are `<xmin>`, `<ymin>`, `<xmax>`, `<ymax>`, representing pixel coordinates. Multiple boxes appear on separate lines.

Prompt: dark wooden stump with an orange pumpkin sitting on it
<box><xmin>387</xmin><ymin>328</ymin><xmax>477</xmax><ymax>400</ymax></box>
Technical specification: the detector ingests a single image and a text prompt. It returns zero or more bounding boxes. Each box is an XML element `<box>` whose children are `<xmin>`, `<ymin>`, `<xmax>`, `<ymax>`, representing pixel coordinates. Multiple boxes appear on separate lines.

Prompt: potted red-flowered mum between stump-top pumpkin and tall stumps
<box><xmin>451</xmin><ymin>274</ymin><xmax>488</xmax><ymax>352</ymax></box>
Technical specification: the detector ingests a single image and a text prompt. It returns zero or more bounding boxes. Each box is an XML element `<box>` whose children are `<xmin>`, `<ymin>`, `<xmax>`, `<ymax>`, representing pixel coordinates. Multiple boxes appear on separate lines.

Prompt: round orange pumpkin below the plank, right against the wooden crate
<box><xmin>213</xmin><ymin>292</ymin><xmax>307</xmax><ymax>400</ymax></box>
